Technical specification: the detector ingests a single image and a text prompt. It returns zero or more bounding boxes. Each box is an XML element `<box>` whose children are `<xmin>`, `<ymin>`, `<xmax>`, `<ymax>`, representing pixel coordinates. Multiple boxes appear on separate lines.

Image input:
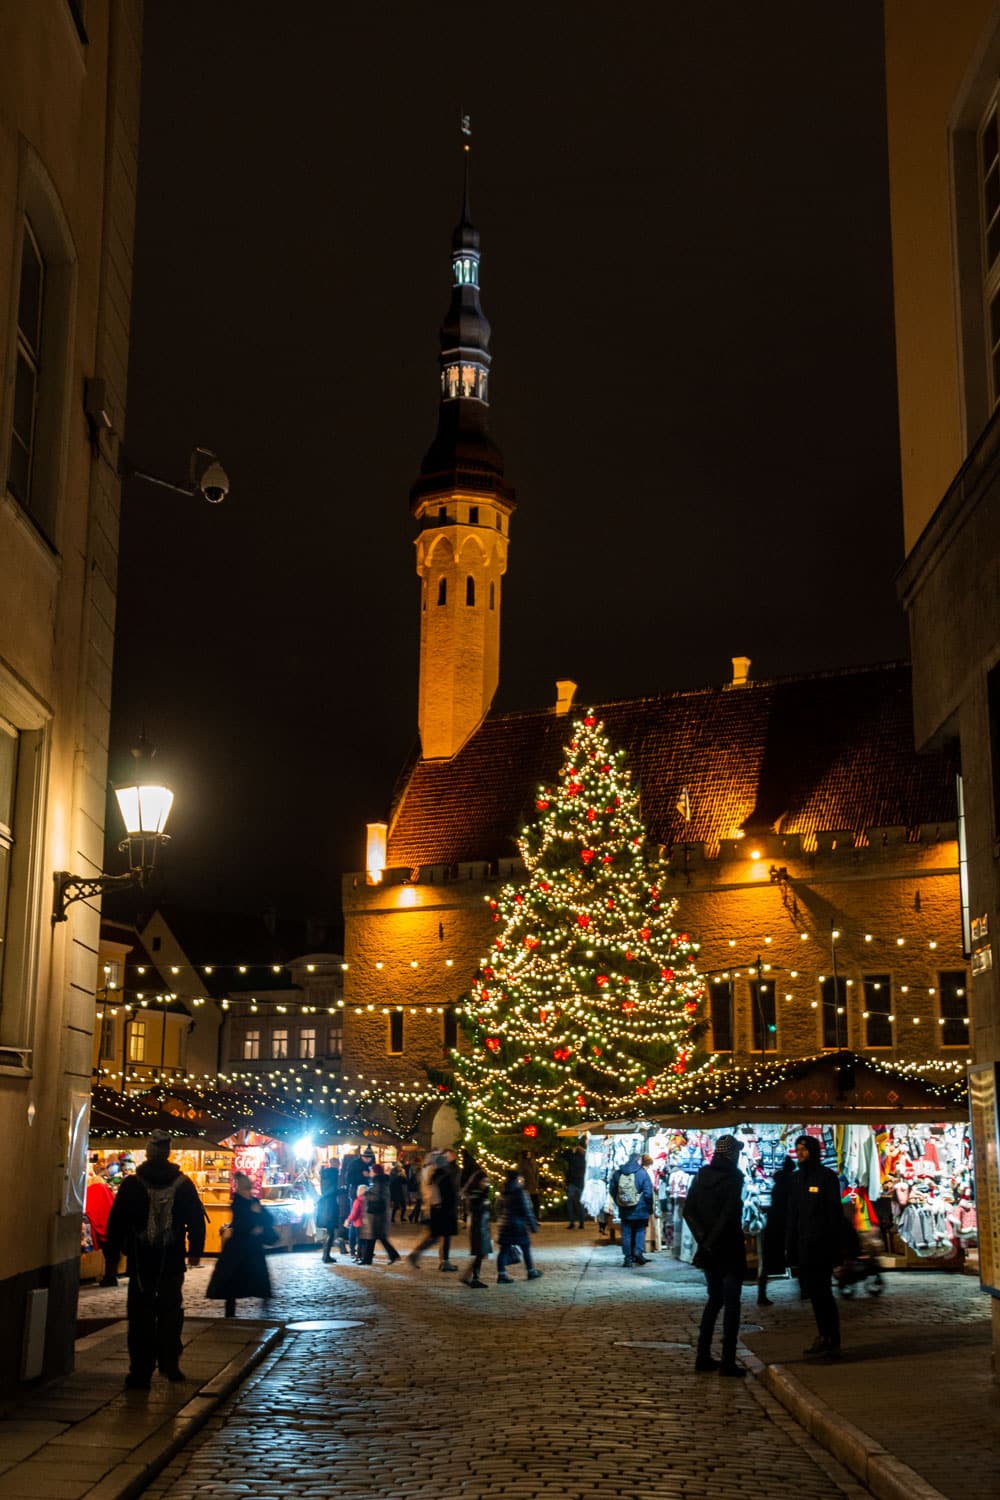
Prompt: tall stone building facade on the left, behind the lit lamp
<box><xmin>0</xmin><ymin>0</ymin><xmax>142</xmax><ymax>1389</ymax></box>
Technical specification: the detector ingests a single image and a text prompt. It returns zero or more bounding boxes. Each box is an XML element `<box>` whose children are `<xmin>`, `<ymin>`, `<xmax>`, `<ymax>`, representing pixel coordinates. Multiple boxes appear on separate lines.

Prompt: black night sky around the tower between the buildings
<box><xmin>108</xmin><ymin>0</ymin><xmax>906</xmax><ymax>915</ymax></box>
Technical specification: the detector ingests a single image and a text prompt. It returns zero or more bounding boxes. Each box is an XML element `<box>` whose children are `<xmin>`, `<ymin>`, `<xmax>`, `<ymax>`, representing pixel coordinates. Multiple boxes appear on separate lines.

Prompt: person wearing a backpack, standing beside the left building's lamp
<box><xmin>106</xmin><ymin>1130</ymin><xmax>205</xmax><ymax>1391</ymax></box>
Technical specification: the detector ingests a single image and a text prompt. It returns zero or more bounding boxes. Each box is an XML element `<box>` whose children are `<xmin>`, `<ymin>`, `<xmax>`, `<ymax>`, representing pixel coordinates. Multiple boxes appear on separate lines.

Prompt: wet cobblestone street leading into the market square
<box><xmin>74</xmin><ymin>1226</ymin><xmax>988</xmax><ymax>1500</ymax></box>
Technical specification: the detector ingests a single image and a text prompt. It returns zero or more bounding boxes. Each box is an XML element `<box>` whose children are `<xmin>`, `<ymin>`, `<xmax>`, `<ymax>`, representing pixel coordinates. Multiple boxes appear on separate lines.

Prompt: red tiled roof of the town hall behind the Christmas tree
<box><xmin>388</xmin><ymin>663</ymin><xmax>955</xmax><ymax>869</ymax></box>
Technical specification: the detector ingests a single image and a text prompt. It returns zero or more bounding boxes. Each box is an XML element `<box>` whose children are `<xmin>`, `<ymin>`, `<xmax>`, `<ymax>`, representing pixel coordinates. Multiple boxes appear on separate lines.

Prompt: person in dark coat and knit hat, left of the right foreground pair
<box><xmin>684</xmin><ymin>1136</ymin><xmax>747</xmax><ymax>1376</ymax></box>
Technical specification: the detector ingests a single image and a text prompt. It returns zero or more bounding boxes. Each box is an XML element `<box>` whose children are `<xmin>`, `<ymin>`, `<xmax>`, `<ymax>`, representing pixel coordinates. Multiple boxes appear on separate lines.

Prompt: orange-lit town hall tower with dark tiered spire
<box><xmin>409</xmin><ymin>126</ymin><xmax>514</xmax><ymax>759</ymax></box>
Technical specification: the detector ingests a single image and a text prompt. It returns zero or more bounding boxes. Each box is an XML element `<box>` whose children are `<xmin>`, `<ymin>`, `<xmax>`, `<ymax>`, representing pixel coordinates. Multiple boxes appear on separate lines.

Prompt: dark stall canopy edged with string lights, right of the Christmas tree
<box><xmin>562</xmin><ymin>1052</ymin><xmax>969</xmax><ymax>1134</ymax></box>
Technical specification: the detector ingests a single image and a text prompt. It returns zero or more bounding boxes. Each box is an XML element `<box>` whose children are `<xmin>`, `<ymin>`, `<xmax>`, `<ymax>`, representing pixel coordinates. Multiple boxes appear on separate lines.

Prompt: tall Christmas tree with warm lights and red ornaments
<box><xmin>451</xmin><ymin>713</ymin><xmax>703</xmax><ymax>1167</ymax></box>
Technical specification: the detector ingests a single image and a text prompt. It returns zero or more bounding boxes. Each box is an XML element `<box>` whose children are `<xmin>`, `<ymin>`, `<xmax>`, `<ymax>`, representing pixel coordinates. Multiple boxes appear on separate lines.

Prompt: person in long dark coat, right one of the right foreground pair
<box><xmin>787</xmin><ymin>1136</ymin><xmax>846</xmax><ymax>1358</ymax></box>
